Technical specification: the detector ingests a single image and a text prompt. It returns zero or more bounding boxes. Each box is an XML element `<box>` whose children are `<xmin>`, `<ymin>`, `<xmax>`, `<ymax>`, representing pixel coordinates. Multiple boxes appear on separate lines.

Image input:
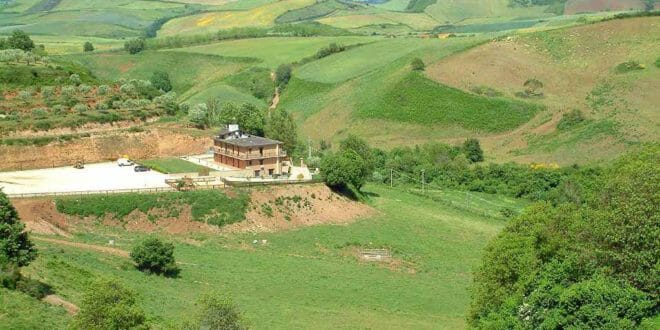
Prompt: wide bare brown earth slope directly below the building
<box><xmin>221</xmin><ymin>184</ymin><xmax>376</xmax><ymax>233</ymax></box>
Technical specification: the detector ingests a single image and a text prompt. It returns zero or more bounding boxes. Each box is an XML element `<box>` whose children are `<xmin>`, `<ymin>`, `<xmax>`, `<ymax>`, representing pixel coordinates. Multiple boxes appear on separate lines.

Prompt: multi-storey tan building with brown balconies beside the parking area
<box><xmin>213</xmin><ymin>125</ymin><xmax>287</xmax><ymax>177</ymax></box>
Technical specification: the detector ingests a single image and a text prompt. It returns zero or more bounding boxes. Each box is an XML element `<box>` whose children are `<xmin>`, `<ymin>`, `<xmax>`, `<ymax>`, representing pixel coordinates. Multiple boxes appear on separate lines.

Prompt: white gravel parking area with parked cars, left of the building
<box><xmin>0</xmin><ymin>162</ymin><xmax>169</xmax><ymax>195</ymax></box>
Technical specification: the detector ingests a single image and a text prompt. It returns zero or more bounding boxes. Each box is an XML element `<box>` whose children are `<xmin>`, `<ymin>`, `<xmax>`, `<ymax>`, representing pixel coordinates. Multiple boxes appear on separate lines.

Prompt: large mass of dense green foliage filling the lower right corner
<box><xmin>469</xmin><ymin>146</ymin><xmax>660</xmax><ymax>329</ymax></box>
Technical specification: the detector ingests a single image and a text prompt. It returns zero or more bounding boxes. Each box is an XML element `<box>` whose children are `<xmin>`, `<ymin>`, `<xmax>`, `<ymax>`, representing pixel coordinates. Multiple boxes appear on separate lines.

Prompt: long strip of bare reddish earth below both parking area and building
<box><xmin>12</xmin><ymin>184</ymin><xmax>376</xmax><ymax>237</ymax></box>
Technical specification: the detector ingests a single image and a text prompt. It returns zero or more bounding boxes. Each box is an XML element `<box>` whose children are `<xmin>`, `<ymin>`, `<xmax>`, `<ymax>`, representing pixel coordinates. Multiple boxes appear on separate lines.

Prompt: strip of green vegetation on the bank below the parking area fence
<box><xmin>56</xmin><ymin>190</ymin><xmax>249</xmax><ymax>226</ymax></box>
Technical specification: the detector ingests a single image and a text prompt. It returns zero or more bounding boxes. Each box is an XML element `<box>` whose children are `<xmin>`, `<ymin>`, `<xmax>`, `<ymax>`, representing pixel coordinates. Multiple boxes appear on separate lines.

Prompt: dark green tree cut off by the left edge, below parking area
<box><xmin>0</xmin><ymin>190</ymin><xmax>37</xmax><ymax>267</ymax></box>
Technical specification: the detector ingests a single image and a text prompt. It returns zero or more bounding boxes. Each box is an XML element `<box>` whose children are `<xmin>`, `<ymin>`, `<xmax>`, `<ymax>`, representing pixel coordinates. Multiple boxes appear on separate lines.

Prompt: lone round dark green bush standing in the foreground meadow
<box><xmin>131</xmin><ymin>237</ymin><xmax>179</xmax><ymax>276</ymax></box>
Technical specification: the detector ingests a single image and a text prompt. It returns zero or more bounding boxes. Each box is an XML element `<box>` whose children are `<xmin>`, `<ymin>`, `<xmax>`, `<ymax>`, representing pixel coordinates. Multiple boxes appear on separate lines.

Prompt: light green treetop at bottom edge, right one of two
<box><xmin>184</xmin><ymin>293</ymin><xmax>247</xmax><ymax>330</ymax></box>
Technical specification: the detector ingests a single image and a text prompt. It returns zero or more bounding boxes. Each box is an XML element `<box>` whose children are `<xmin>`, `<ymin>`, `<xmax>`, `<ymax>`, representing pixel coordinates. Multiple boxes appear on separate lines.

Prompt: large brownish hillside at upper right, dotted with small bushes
<box><xmin>427</xmin><ymin>17</ymin><xmax>660</xmax><ymax>164</ymax></box>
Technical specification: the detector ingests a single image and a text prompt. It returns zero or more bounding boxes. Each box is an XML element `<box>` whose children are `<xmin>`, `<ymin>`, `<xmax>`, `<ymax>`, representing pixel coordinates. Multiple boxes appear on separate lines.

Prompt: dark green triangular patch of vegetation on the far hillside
<box><xmin>358</xmin><ymin>72</ymin><xmax>540</xmax><ymax>132</ymax></box>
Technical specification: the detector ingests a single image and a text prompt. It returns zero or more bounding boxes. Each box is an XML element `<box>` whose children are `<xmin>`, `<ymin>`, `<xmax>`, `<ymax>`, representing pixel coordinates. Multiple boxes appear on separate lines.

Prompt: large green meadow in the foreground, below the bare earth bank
<box><xmin>16</xmin><ymin>186</ymin><xmax>504</xmax><ymax>329</ymax></box>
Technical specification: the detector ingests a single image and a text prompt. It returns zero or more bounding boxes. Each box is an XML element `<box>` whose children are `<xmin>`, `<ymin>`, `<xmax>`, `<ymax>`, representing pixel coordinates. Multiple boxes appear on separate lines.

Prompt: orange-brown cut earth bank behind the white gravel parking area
<box><xmin>0</xmin><ymin>128</ymin><xmax>212</xmax><ymax>170</ymax></box>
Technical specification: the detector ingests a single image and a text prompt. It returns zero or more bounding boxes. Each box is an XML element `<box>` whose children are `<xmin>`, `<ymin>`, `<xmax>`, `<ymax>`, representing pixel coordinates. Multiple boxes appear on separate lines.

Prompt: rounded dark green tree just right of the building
<box><xmin>320</xmin><ymin>150</ymin><xmax>370</xmax><ymax>191</ymax></box>
